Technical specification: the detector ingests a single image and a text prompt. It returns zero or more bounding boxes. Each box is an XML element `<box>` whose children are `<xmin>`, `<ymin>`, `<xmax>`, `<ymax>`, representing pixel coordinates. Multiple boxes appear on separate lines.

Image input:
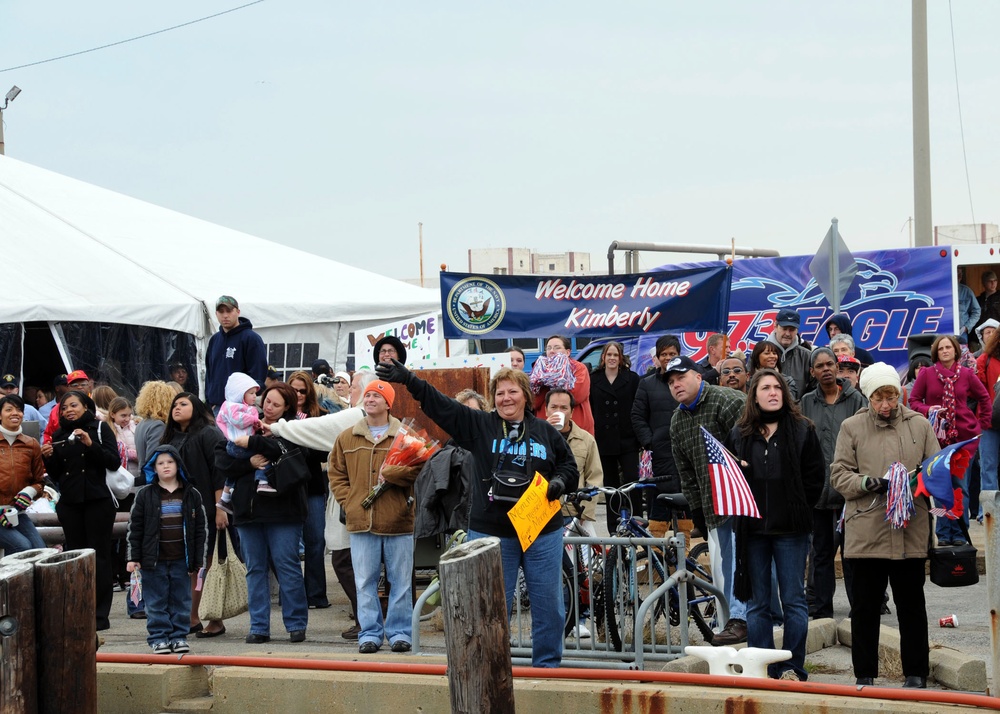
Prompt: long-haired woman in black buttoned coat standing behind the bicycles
<box><xmin>590</xmin><ymin>342</ymin><xmax>639</xmax><ymax>533</ymax></box>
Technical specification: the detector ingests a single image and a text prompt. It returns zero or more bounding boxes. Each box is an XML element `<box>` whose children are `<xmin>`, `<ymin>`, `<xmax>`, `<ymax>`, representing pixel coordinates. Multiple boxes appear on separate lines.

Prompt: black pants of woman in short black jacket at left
<box><xmin>56</xmin><ymin>497</ymin><xmax>115</xmax><ymax>630</ymax></box>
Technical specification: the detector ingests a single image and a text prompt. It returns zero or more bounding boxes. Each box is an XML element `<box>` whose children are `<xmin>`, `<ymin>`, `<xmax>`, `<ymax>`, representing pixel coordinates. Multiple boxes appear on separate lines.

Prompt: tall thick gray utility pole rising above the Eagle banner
<box><xmin>912</xmin><ymin>0</ymin><xmax>934</xmax><ymax>246</ymax></box>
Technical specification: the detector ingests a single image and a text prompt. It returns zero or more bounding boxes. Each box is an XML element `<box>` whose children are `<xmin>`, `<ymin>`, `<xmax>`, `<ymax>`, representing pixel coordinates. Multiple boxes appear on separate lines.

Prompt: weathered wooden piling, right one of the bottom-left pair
<box><xmin>34</xmin><ymin>548</ymin><xmax>97</xmax><ymax>714</ymax></box>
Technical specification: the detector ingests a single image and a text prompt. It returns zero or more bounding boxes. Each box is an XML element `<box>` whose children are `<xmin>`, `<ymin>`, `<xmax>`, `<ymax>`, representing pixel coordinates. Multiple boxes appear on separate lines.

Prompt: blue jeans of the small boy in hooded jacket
<box><xmin>139</xmin><ymin>558</ymin><xmax>191</xmax><ymax>645</ymax></box>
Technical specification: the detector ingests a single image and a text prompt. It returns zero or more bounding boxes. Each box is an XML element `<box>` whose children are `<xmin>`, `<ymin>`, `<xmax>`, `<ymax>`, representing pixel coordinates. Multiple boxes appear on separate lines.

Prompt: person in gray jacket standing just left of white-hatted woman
<box><xmin>799</xmin><ymin>347</ymin><xmax>868</xmax><ymax>619</ymax></box>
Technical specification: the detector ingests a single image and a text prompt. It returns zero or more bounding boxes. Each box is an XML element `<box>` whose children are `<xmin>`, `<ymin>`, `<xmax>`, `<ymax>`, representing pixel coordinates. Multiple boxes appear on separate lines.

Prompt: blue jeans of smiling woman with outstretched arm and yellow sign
<box><xmin>466</xmin><ymin>530</ymin><xmax>566</xmax><ymax>667</ymax></box>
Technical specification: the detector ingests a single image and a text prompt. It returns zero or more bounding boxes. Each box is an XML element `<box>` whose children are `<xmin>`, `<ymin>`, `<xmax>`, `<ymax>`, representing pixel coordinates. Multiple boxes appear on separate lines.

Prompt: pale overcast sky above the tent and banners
<box><xmin>0</xmin><ymin>0</ymin><xmax>1000</xmax><ymax>281</ymax></box>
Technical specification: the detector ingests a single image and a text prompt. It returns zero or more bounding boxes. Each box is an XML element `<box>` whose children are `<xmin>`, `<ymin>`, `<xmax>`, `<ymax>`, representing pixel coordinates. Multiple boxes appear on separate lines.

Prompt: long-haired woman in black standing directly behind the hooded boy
<box><xmin>160</xmin><ymin>392</ymin><xmax>228</xmax><ymax>637</ymax></box>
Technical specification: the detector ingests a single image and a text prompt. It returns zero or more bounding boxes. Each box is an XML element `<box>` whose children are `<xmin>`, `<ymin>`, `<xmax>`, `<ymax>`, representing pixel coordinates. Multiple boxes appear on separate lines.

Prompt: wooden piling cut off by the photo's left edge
<box><xmin>0</xmin><ymin>563</ymin><xmax>38</xmax><ymax>714</ymax></box>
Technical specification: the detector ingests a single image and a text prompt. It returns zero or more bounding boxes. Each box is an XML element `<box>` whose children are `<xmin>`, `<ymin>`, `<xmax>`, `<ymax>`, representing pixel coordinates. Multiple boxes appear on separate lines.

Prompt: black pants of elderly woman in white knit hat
<box><xmin>851</xmin><ymin>558</ymin><xmax>930</xmax><ymax>677</ymax></box>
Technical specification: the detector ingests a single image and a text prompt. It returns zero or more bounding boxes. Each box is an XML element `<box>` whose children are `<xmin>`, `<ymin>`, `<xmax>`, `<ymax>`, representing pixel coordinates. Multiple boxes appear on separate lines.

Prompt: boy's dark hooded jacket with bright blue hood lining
<box><xmin>126</xmin><ymin>444</ymin><xmax>208</xmax><ymax>573</ymax></box>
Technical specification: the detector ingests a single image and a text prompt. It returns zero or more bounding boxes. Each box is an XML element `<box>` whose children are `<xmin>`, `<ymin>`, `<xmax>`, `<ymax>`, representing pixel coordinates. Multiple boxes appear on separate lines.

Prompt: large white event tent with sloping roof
<box><xmin>0</xmin><ymin>156</ymin><xmax>440</xmax><ymax>392</ymax></box>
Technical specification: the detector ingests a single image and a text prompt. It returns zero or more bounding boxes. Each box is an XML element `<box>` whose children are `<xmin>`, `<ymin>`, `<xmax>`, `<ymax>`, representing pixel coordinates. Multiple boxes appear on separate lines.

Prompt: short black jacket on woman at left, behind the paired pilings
<box><xmin>45</xmin><ymin>411</ymin><xmax>122</xmax><ymax>503</ymax></box>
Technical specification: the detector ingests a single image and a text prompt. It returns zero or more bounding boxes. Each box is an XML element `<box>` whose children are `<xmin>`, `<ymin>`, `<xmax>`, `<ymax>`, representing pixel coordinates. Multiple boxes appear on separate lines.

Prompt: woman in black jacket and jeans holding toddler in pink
<box><xmin>215</xmin><ymin>382</ymin><xmax>309</xmax><ymax>645</ymax></box>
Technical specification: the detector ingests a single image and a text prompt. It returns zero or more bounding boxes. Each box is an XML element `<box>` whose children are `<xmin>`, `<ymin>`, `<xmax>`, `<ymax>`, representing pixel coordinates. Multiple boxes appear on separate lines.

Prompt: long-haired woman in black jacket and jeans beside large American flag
<box><xmin>729</xmin><ymin>368</ymin><xmax>826</xmax><ymax>681</ymax></box>
